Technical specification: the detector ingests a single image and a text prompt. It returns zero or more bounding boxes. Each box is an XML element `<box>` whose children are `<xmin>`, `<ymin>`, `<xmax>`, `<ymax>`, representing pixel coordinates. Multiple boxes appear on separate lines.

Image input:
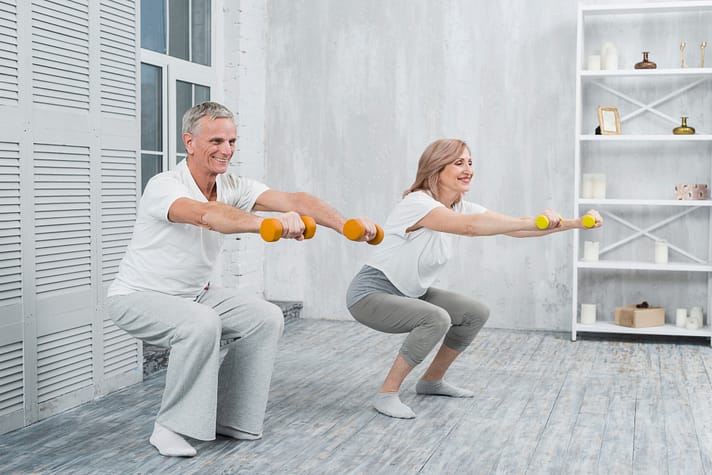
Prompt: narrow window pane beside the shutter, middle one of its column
<box><xmin>141</xmin><ymin>63</ymin><xmax>163</xmax><ymax>152</ymax></box>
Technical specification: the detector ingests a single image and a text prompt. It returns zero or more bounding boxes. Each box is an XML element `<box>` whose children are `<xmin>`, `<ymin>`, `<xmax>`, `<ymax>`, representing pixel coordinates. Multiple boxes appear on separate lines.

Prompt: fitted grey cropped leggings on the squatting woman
<box><xmin>349</xmin><ymin>287</ymin><xmax>489</xmax><ymax>366</ymax></box>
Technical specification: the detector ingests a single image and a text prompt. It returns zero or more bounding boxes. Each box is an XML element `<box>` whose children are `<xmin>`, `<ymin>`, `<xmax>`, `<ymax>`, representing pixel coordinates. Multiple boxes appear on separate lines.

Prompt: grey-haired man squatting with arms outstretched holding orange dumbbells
<box><xmin>106</xmin><ymin>102</ymin><xmax>376</xmax><ymax>457</ymax></box>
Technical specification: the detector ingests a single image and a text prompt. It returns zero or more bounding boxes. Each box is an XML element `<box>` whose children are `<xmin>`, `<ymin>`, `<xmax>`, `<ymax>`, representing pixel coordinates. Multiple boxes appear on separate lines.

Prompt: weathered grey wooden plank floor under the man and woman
<box><xmin>0</xmin><ymin>320</ymin><xmax>712</xmax><ymax>475</ymax></box>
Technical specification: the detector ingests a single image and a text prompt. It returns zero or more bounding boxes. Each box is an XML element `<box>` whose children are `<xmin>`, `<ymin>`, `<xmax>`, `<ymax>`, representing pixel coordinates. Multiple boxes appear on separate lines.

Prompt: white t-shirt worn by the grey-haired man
<box><xmin>107</xmin><ymin>160</ymin><xmax>268</xmax><ymax>298</ymax></box>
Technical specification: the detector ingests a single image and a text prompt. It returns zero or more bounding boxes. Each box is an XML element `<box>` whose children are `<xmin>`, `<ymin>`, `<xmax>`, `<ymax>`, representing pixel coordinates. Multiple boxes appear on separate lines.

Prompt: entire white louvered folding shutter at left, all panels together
<box><xmin>0</xmin><ymin>0</ymin><xmax>142</xmax><ymax>433</ymax></box>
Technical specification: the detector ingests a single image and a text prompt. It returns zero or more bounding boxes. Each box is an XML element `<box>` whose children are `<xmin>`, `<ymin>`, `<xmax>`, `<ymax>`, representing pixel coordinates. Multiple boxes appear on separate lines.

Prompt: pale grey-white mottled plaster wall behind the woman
<box><xmin>241</xmin><ymin>0</ymin><xmax>680</xmax><ymax>330</ymax></box>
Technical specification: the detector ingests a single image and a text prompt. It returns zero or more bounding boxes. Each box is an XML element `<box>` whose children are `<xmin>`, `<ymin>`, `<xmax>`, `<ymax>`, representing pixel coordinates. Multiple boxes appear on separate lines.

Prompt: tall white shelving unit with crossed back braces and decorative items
<box><xmin>571</xmin><ymin>1</ymin><xmax>712</xmax><ymax>345</ymax></box>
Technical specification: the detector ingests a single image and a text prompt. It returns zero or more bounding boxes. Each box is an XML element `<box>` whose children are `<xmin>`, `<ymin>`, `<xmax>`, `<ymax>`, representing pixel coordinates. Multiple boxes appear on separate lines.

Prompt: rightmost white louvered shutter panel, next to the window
<box><xmin>98</xmin><ymin>0</ymin><xmax>143</xmax><ymax>394</ymax></box>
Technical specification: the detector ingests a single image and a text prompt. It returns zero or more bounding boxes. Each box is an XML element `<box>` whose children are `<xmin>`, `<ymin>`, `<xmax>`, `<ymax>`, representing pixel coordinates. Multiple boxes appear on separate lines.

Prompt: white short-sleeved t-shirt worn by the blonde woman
<box><xmin>366</xmin><ymin>191</ymin><xmax>487</xmax><ymax>297</ymax></box>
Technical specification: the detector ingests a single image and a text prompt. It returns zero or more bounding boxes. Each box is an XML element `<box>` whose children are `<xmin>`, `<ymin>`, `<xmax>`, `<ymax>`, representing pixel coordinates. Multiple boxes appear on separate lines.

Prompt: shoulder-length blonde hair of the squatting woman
<box><xmin>403</xmin><ymin>139</ymin><xmax>470</xmax><ymax>205</ymax></box>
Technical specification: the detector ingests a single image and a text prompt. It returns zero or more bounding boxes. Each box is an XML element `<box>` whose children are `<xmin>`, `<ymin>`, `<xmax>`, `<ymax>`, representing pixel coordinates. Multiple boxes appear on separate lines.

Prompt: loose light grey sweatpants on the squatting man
<box><xmin>106</xmin><ymin>287</ymin><xmax>284</xmax><ymax>440</ymax></box>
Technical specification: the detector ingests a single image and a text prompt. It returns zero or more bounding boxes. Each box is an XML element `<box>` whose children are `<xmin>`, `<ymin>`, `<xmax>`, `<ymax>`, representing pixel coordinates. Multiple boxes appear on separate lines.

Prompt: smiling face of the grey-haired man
<box><xmin>183</xmin><ymin>117</ymin><xmax>237</xmax><ymax>175</ymax></box>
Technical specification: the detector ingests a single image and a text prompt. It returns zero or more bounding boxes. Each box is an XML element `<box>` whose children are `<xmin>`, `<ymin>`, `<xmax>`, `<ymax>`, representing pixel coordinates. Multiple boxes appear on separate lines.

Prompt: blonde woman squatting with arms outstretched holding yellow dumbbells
<box><xmin>346</xmin><ymin>139</ymin><xmax>602</xmax><ymax>419</ymax></box>
